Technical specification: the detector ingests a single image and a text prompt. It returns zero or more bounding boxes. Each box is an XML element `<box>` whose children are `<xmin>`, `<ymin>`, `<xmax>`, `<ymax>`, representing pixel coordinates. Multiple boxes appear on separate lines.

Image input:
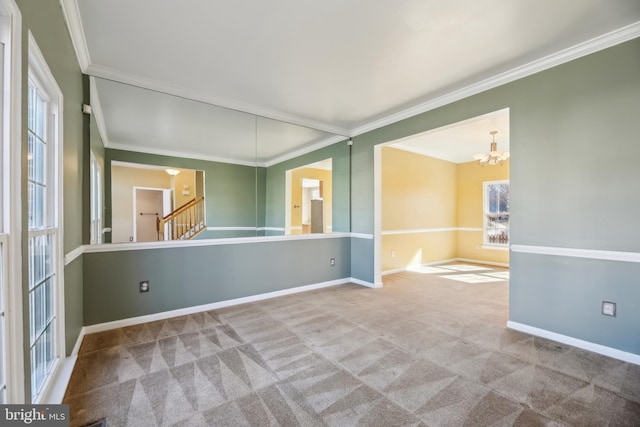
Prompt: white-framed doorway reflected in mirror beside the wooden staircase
<box><xmin>133</xmin><ymin>187</ymin><xmax>174</xmax><ymax>242</ymax></box>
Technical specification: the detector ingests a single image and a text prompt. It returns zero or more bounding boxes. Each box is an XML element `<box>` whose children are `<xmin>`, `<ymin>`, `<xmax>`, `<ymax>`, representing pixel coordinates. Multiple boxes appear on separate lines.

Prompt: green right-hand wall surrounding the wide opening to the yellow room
<box><xmin>351</xmin><ymin>39</ymin><xmax>640</xmax><ymax>354</ymax></box>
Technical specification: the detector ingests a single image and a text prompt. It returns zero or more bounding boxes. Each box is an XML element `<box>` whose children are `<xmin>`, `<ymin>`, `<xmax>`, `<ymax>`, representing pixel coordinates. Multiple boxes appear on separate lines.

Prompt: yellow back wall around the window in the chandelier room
<box><xmin>458</xmin><ymin>160</ymin><xmax>509</xmax><ymax>264</ymax></box>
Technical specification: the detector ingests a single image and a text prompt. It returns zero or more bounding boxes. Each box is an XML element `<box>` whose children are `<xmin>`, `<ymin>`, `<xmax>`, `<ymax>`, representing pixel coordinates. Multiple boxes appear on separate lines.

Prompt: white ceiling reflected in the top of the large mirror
<box><xmin>91</xmin><ymin>78</ymin><xmax>344</xmax><ymax>165</ymax></box>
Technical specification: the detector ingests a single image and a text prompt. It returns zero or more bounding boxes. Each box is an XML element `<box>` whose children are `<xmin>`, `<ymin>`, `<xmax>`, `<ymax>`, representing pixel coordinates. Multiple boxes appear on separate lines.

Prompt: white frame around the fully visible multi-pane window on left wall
<box><xmin>28</xmin><ymin>31</ymin><xmax>65</xmax><ymax>403</ymax></box>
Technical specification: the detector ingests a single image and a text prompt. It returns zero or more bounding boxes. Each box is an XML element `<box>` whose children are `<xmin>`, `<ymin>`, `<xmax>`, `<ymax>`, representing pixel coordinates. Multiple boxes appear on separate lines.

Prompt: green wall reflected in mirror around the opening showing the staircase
<box><xmin>105</xmin><ymin>148</ymin><xmax>259</xmax><ymax>238</ymax></box>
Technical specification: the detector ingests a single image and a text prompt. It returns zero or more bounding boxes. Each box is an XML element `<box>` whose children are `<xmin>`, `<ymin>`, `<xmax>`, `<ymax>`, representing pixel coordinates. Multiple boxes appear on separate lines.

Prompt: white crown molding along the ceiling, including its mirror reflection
<box><xmin>77</xmin><ymin>17</ymin><xmax>640</xmax><ymax>167</ymax></box>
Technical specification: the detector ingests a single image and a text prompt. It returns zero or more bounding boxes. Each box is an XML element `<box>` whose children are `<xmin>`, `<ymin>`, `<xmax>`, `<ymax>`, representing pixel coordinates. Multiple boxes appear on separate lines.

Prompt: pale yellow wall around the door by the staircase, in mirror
<box><xmin>111</xmin><ymin>166</ymin><xmax>171</xmax><ymax>243</ymax></box>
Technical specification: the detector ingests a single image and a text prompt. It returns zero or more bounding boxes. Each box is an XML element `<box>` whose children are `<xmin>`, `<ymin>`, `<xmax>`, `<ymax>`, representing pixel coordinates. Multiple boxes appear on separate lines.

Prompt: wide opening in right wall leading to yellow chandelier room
<box><xmin>374</xmin><ymin>108</ymin><xmax>510</xmax><ymax>286</ymax></box>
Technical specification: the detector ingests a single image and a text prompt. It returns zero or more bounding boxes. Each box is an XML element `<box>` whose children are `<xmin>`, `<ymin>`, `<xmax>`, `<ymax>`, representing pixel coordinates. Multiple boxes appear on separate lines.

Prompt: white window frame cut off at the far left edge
<box><xmin>0</xmin><ymin>0</ymin><xmax>26</xmax><ymax>404</ymax></box>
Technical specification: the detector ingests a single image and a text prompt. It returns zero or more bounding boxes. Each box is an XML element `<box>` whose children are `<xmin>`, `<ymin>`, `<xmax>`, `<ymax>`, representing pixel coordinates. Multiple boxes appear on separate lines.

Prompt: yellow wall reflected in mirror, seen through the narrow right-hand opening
<box><xmin>291</xmin><ymin>168</ymin><xmax>333</xmax><ymax>234</ymax></box>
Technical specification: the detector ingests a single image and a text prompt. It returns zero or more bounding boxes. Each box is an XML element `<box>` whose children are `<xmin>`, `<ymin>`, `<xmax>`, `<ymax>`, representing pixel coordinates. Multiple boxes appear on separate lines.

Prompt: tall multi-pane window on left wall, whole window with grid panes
<box><xmin>27</xmin><ymin>32</ymin><xmax>64</xmax><ymax>403</ymax></box>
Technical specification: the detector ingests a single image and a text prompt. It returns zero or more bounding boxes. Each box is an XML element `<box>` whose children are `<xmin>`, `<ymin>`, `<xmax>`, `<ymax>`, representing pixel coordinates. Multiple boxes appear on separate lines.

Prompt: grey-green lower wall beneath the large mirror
<box><xmin>84</xmin><ymin>237</ymin><xmax>351</xmax><ymax>325</ymax></box>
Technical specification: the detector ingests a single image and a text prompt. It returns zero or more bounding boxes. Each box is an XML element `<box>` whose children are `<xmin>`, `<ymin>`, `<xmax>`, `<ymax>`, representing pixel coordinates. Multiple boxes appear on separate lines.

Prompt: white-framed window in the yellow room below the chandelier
<box><xmin>483</xmin><ymin>181</ymin><xmax>509</xmax><ymax>247</ymax></box>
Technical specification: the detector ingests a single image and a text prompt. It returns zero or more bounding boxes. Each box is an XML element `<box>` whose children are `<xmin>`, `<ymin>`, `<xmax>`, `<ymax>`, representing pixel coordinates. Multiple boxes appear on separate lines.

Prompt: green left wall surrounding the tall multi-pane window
<box><xmin>16</xmin><ymin>0</ymin><xmax>88</xmax><ymax>401</ymax></box>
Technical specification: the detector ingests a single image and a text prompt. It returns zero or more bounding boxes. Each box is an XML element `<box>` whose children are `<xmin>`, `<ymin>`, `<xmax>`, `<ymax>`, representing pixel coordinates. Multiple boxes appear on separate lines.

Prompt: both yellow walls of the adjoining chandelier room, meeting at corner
<box><xmin>382</xmin><ymin>147</ymin><xmax>509</xmax><ymax>271</ymax></box>
